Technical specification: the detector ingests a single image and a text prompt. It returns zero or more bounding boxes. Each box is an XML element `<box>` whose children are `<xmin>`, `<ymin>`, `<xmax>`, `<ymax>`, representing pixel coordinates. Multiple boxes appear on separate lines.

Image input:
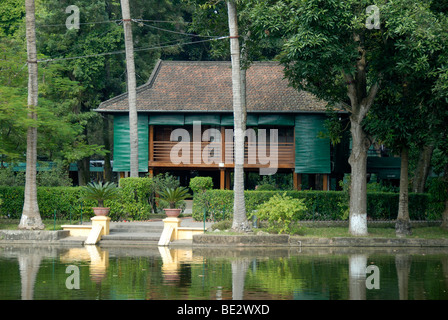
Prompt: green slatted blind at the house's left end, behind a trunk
<box><xmin>113</xmin><ymin>114</ymin><xmax>149</xmax><ymax>172</ymax></box>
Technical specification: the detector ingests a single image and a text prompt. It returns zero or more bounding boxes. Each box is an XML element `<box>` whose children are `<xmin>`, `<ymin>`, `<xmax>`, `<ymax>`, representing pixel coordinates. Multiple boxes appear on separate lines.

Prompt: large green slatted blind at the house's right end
<box><xmin>294</xmin><ymin>114</ymin><xmax>331</xmax><ymax>173</ymax></box>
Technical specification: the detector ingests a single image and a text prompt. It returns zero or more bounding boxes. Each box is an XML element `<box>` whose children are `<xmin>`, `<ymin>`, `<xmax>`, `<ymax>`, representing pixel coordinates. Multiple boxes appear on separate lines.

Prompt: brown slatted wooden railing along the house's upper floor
<box><xmin>149</xmin><ymin>141</ymin><xmax>294</xmax><ymax>168</ymax></box>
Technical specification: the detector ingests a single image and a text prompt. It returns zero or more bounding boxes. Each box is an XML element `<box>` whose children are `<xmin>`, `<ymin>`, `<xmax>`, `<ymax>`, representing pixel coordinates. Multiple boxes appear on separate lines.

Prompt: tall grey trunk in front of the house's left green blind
<box><xmin>121</xmin><ymin>0</ymin><xmax>138</xmax><ymax>177</ymax></box>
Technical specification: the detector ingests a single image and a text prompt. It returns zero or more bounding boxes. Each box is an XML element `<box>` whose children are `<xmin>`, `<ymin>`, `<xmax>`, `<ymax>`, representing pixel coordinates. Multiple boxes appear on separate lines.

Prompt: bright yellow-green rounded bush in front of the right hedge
<box><xmin>256</xmin><ymin>193</ymin><xmax>306</xmax><ymax>233</ymax></box>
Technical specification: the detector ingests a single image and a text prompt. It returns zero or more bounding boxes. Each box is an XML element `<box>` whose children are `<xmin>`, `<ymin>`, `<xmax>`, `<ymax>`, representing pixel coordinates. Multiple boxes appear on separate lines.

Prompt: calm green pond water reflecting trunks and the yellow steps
<box><xmin>0</xmin><ymin>245</ymin><xmax>448</xmax><ymax>300</ymax></box>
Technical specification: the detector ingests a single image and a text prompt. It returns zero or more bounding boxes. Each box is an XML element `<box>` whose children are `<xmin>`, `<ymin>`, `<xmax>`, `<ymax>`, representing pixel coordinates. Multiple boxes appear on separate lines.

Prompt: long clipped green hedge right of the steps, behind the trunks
<box><xmin>193</xmin><ymin>190</ymin><xmax>442</xmax><ymax>220</ymax></box>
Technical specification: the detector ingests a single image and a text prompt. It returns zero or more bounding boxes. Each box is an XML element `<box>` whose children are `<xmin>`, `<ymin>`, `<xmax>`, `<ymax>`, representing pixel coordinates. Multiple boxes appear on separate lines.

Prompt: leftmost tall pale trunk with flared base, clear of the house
<box><xmin>19</xmin><ymin>0</ymin><xmax>44</xmax><ymax>229</ymax></box>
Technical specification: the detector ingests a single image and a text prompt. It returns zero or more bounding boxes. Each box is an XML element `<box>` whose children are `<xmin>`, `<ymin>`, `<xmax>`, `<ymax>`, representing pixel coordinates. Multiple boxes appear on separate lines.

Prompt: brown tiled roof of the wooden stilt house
<box><xmin>96</xmin><ymin>61</ymin><xmax>326</xmax><ymax>112</ymax></box>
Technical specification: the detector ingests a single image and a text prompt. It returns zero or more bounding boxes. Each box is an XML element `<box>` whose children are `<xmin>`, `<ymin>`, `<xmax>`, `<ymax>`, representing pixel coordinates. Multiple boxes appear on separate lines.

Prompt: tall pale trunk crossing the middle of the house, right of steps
<box><xmin>227</xmin><ymin>0</ymin><xmax>251</xmax><ymax>232</ymax></box>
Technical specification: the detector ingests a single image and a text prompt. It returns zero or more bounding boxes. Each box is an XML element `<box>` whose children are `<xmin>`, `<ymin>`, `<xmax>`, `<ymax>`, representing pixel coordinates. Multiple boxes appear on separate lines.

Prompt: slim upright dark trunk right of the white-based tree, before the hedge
<box><xmin>395</xmin><ymin>147</ymin><xmax>411</xmax><ymax>237</ymax></box>
